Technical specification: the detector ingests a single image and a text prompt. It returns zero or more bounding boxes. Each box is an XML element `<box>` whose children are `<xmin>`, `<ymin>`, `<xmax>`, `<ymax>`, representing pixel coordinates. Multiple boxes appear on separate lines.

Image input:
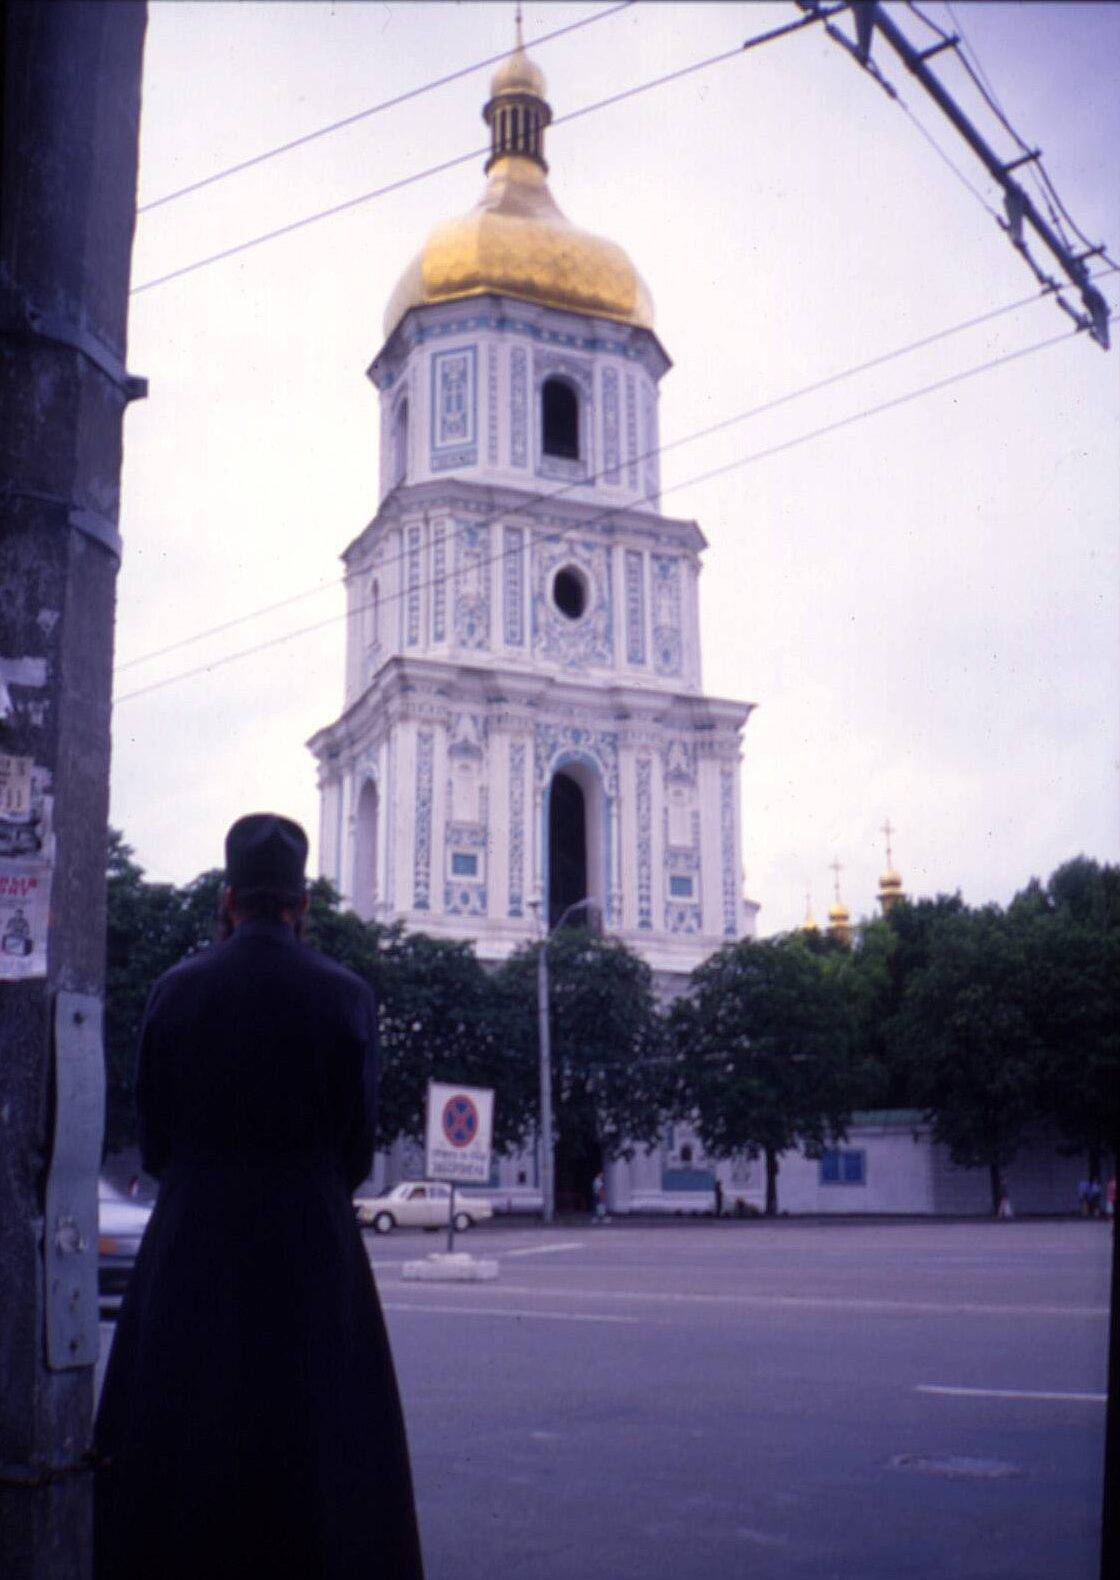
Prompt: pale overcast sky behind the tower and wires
<box><xmin>111</xmin><ymin>0</ymin><xmax>1120</xmax><ymax>932</ymax></box>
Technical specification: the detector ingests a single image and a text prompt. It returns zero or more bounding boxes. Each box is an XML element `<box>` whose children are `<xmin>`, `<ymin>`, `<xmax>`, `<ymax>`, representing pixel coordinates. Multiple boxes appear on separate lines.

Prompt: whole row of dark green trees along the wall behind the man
<box><xmin>106</xmin><ymin>833</ymin><xmax>1120</xmax><ymax>1210</ymax></box>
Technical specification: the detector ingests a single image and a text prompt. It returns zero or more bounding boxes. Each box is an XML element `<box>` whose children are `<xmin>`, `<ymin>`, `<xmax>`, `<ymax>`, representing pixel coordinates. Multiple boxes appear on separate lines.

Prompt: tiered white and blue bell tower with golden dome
<box><xmin>310</xmin><ymin>22</ymin><xmax>755</xmax><ymax>975</ymax></box>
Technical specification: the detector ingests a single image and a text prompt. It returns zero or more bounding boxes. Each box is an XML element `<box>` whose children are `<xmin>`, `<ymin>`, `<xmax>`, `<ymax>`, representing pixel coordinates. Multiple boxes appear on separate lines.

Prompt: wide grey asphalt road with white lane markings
<box><xmin>98</xmin><ymin>1221</ymin><xmax>1109</xmax><ymax>1580</ymax></box>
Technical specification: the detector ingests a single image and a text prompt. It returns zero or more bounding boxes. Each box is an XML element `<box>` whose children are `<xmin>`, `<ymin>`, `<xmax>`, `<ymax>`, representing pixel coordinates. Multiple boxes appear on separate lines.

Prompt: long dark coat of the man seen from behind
<box><xmin>95</xmin><ymin>921</ymin><xmax>422</xmax><ymax>1580</ymax></box>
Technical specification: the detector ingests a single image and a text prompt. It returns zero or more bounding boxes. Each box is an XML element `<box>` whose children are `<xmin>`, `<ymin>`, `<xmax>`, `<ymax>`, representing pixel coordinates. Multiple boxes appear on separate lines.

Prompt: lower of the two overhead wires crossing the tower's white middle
<box><xmin>114</xmin><ymin>304</ymin><xmax>1120</xmax><ymax>706</ymax></box>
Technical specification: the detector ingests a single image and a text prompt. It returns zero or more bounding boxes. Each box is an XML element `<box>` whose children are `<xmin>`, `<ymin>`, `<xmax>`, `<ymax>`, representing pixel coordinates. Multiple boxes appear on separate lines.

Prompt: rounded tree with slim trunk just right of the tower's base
<box><xmin>670</xmin><ymin>934</ymin><xmax>853</xmax><ymax>1217</ymax></box>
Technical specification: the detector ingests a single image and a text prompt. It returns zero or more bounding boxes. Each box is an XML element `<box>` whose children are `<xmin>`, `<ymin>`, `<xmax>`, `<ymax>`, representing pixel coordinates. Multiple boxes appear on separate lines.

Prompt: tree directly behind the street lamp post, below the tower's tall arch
<box><xmin>494</xmin><ymin>927</ymin><xmax>665</xmax><ymax>1206</ymax></box>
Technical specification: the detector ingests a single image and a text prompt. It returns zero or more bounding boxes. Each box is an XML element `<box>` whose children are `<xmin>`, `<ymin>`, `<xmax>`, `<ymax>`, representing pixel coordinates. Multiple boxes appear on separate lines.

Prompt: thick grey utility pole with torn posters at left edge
<box><xmin>0</xmin><ymin>0</ymin><xmax>147</xmax><ymax>1580</ymax></box>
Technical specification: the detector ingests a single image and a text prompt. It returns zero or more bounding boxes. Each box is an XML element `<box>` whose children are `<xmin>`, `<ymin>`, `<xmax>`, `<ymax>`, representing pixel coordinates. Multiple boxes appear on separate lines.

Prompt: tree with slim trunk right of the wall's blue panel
<box><xmin>891</xmin><ymin>905</ymin><xmax>1041</xmax><ymax>1213</ymax></box>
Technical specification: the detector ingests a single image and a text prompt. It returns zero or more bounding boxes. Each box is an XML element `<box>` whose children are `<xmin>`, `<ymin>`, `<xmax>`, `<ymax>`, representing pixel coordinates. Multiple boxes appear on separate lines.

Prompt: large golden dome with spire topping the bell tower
<box><xmin>385</xmin><ymin>19</ymin><xmax>654</xmax><ymax>340</ymax></box>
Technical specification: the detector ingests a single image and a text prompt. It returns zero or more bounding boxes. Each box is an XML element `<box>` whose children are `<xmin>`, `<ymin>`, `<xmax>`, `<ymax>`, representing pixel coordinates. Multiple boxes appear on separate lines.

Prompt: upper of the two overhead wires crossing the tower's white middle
<box><xmin>114</xmin><ymin>265</ymin><xmax>1120</xmax><ymax>675</ymax></box>
